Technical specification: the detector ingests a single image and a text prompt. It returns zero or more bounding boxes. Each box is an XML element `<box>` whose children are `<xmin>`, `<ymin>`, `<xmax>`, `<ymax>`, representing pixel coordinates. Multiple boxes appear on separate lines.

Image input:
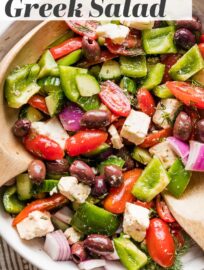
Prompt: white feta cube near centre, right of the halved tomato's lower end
<box><xmin>120</xmin><ymin>110</ymin><xmax>151</xmax><ymax>145</ymax></box>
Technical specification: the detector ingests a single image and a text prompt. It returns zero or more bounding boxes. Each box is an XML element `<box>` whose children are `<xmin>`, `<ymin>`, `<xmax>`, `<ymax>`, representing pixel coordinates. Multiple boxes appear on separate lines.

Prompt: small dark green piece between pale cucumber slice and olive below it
<box><xmin>77</xmin><ymin>95</ymin><xmax>101</xmax><ymax>111</ymax></box>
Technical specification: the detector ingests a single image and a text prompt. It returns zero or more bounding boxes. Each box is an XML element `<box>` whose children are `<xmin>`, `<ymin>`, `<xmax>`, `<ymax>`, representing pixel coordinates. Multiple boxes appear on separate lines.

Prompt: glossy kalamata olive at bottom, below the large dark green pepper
<box><xmin>84</xmin><ymin>234</ymin><xmax>114</xmax><ymax>255</ymax></box>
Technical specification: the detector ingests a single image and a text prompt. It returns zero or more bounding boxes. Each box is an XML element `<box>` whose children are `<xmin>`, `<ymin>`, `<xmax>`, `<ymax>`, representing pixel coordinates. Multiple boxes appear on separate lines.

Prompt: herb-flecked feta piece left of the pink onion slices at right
<box><xmin>149</xmin><ymin>141</ymin><xmax>177</xmax><ymax>169</ymax></box>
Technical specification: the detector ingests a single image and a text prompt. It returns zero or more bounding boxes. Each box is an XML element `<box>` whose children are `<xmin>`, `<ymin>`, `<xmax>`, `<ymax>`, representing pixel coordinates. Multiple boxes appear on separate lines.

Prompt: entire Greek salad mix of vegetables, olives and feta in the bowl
<box><xmin>3</xmin><ymin>17</ymin><xmax>204</xmax><ymax>270</ymax></box>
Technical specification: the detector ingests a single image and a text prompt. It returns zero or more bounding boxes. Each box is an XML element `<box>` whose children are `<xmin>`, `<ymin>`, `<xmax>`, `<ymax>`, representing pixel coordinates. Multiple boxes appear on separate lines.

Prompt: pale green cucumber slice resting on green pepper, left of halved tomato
<box><xmin>76</xmin><ymin>74</ymin><xmax>100</xmax><ymax>97</ymax></box>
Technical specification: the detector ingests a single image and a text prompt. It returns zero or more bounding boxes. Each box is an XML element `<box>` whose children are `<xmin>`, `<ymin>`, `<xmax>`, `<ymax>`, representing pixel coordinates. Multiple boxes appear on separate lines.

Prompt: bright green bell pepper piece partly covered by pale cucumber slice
<box><xmin>59</xmin><ymin>66</ymin><xmax>88</xmax><ymax>102</ymax></box>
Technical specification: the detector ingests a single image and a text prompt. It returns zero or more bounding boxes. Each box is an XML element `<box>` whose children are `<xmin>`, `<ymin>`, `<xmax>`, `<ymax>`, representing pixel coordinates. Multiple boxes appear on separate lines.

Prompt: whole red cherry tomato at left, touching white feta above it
<box><xmin>23</xmin><ymin>133</ymin><xmax>64</xmax><ymax>160</ymax></box>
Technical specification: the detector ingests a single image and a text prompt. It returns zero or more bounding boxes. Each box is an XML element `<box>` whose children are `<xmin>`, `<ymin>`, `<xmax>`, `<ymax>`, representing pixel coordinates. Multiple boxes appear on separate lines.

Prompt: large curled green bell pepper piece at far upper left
<box><xmin>4</xmin><ymin>64</ymin><xmax>40</xmax><ymax>109</ymax></box>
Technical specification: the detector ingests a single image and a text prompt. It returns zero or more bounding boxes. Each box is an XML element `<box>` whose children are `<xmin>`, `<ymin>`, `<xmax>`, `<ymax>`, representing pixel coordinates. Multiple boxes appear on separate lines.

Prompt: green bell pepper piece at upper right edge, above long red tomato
<box><xmin>169</xmin><ymin>45</ymin><xmax>204</xmax><ymax>81</ymax></box>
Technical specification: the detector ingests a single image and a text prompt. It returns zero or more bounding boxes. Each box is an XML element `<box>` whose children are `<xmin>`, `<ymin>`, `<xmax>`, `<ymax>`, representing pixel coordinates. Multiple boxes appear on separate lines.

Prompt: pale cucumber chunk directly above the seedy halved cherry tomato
<box><xmin>99</xmin><ymin>60</ymin><xmax>121</xmax><ymax>81</ymax></box>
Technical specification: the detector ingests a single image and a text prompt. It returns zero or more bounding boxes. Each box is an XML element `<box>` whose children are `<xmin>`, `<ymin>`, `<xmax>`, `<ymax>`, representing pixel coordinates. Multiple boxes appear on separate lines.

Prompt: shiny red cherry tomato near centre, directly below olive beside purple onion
<box><xmin>66</xmin><ymin>130</ymin><xmax>108</xmax><ymax>157</ymax></box>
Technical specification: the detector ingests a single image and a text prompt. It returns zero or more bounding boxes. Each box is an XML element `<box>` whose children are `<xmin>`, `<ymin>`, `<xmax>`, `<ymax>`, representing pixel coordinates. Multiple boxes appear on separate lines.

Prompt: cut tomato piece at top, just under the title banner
<box><xmin>66</xmin><ymin>20</ymin><xmax>99</xmax><ymax>39</ymax></box>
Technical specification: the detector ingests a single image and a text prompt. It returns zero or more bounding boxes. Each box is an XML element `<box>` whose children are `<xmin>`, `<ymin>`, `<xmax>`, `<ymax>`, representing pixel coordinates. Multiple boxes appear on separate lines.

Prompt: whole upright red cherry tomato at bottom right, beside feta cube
<box><xmin>146</xmin><ymin>218</ymin><xmax>175</xmax><ymax>267</ymax></box>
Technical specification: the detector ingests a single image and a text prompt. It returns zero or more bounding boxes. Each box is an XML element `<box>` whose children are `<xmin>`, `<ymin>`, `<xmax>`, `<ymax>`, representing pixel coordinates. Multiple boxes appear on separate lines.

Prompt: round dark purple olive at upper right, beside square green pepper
<box><xmin>174</xmin><ymin>28</ymin><xmax>196</xmax><ymax>50</ymax></box>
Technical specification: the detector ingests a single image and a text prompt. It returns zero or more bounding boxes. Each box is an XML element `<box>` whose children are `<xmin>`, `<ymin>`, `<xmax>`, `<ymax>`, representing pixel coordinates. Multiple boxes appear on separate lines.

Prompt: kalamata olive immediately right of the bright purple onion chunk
<box><xmin>81</xmin><ymin>110</ymin><xmax>111</xmax><ymax>128</ymax></box>
